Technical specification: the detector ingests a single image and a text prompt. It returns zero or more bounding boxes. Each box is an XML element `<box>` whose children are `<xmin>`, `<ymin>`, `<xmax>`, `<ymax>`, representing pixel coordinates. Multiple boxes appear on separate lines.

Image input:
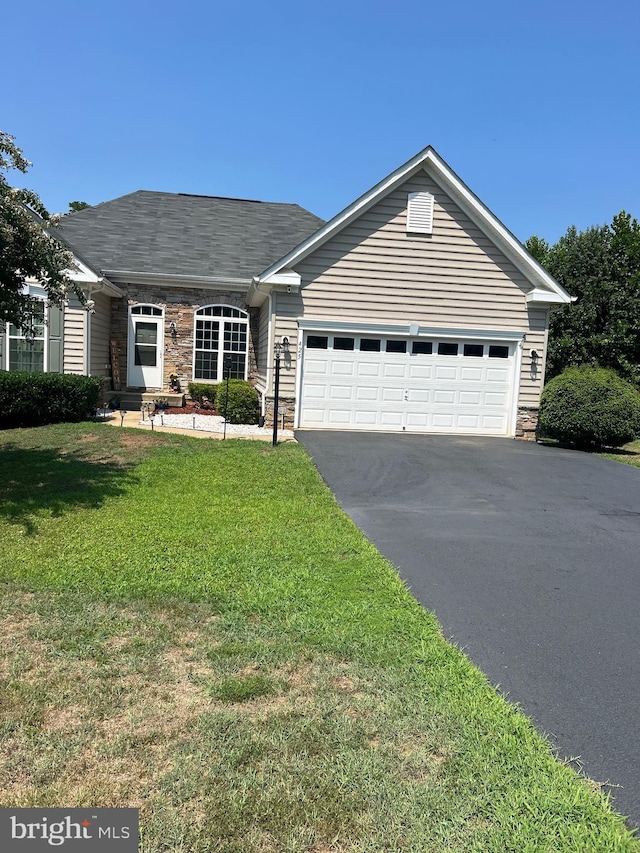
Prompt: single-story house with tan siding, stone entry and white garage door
<box><xmin>0</xmin><ymin>147</ymin><xmax>570</xmax><ymax>436</ymax></box>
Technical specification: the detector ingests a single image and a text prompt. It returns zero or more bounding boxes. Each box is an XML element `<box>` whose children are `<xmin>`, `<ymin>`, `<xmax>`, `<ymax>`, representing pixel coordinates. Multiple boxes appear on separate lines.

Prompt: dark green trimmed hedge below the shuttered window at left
<box><xmin>0</xmin><ymin>371</ymin><xmax>103</xmax><ymax>429</ymax></box>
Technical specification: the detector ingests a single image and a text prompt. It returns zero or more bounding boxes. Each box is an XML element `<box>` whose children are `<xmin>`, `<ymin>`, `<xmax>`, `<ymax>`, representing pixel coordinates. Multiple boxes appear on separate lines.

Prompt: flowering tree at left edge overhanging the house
<box><xmin>0</xmin><ymin>131</ymin><xmax>84</xmax><ymax>335</ymax></box>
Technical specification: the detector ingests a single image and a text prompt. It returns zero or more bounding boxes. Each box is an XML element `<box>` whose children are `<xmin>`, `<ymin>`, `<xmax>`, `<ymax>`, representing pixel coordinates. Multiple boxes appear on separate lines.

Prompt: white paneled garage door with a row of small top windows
<box><xmin>300</xmin><ymin>332</ymin><xmax>516</xmax><ymax>435</ymax></box>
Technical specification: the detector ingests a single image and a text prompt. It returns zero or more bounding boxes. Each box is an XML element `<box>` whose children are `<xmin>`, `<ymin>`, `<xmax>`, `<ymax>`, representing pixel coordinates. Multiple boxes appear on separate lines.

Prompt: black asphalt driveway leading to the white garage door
<box><xmin>296</xmin><ymin>431</ymin><xmax>640</xmax><ymax>826</ymax></box>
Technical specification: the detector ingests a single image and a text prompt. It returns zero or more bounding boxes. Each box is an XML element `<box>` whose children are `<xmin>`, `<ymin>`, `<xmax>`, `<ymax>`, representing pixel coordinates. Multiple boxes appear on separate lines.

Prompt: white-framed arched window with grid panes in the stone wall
<box><xmin>193</xmin><ymin>305</ymin><xmax>249</xmax><ymax>382</ymax></box>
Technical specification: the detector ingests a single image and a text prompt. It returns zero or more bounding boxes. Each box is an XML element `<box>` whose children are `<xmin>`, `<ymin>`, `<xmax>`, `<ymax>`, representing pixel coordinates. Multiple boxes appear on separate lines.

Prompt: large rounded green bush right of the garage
<box><xmin>540</xmin><ymin>365</ymin><xmax>640</xmax><ymax>448</ymax></box>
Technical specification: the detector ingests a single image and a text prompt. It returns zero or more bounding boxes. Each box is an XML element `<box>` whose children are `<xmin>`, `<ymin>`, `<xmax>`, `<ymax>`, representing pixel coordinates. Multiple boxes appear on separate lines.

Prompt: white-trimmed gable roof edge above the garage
<box><xmin>255</xmin><ymin>145</ymin><xmax>571</xmax><ymax>304</ymax></box>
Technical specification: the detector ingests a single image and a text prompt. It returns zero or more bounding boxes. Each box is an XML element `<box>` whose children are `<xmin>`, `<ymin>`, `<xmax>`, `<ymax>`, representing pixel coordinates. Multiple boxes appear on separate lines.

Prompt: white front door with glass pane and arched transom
<box><xmin>127</xmin><ymin>305</ymin><xmax>164</xmax><ymax>389</ymax></box>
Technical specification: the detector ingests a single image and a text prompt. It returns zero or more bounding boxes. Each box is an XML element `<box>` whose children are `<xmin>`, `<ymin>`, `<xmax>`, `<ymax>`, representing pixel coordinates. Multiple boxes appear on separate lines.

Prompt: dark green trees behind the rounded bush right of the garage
<box><xmin>525</xmin><ymin>211</ymin><xmax>640</xmax><ymax>383</ymax></box>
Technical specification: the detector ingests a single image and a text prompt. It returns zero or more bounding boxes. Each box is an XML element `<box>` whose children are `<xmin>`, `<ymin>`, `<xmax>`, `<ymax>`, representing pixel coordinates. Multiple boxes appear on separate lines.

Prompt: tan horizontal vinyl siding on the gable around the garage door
<box><xmin>284</xmin><ymin>172</ymin><xmax>547</xmax><ymax>405</ymax></box>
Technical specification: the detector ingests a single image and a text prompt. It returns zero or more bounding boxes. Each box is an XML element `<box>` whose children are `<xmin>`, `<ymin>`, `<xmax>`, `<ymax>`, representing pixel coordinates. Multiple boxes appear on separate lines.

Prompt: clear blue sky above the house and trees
<box><xmin>5</xmin><ymin>0</ymin><xmax>640</xmax><ymax>242</ymax></box>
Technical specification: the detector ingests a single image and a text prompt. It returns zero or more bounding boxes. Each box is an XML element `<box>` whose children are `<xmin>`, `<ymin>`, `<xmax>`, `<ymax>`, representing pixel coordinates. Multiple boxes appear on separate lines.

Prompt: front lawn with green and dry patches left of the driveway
<box><xmin>0</xmin><ymin>424</ymin><xmax>640</xmax><ymax>853</ymax></box>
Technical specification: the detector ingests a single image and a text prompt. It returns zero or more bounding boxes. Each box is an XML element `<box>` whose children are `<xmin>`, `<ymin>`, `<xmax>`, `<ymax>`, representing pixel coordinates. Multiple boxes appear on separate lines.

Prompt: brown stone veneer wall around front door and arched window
<box><xmin>111</xmin><ymin>284</ymin><xmax>258</xmax><ymax>392</ymax></box>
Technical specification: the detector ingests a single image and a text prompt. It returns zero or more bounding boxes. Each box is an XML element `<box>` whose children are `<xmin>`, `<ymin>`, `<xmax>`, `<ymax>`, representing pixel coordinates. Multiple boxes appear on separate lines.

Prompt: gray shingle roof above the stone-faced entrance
<box><xmin>54</xmin><ymin>190</ymin><xmax>324</xmax><ymax>279</ymax></box>
